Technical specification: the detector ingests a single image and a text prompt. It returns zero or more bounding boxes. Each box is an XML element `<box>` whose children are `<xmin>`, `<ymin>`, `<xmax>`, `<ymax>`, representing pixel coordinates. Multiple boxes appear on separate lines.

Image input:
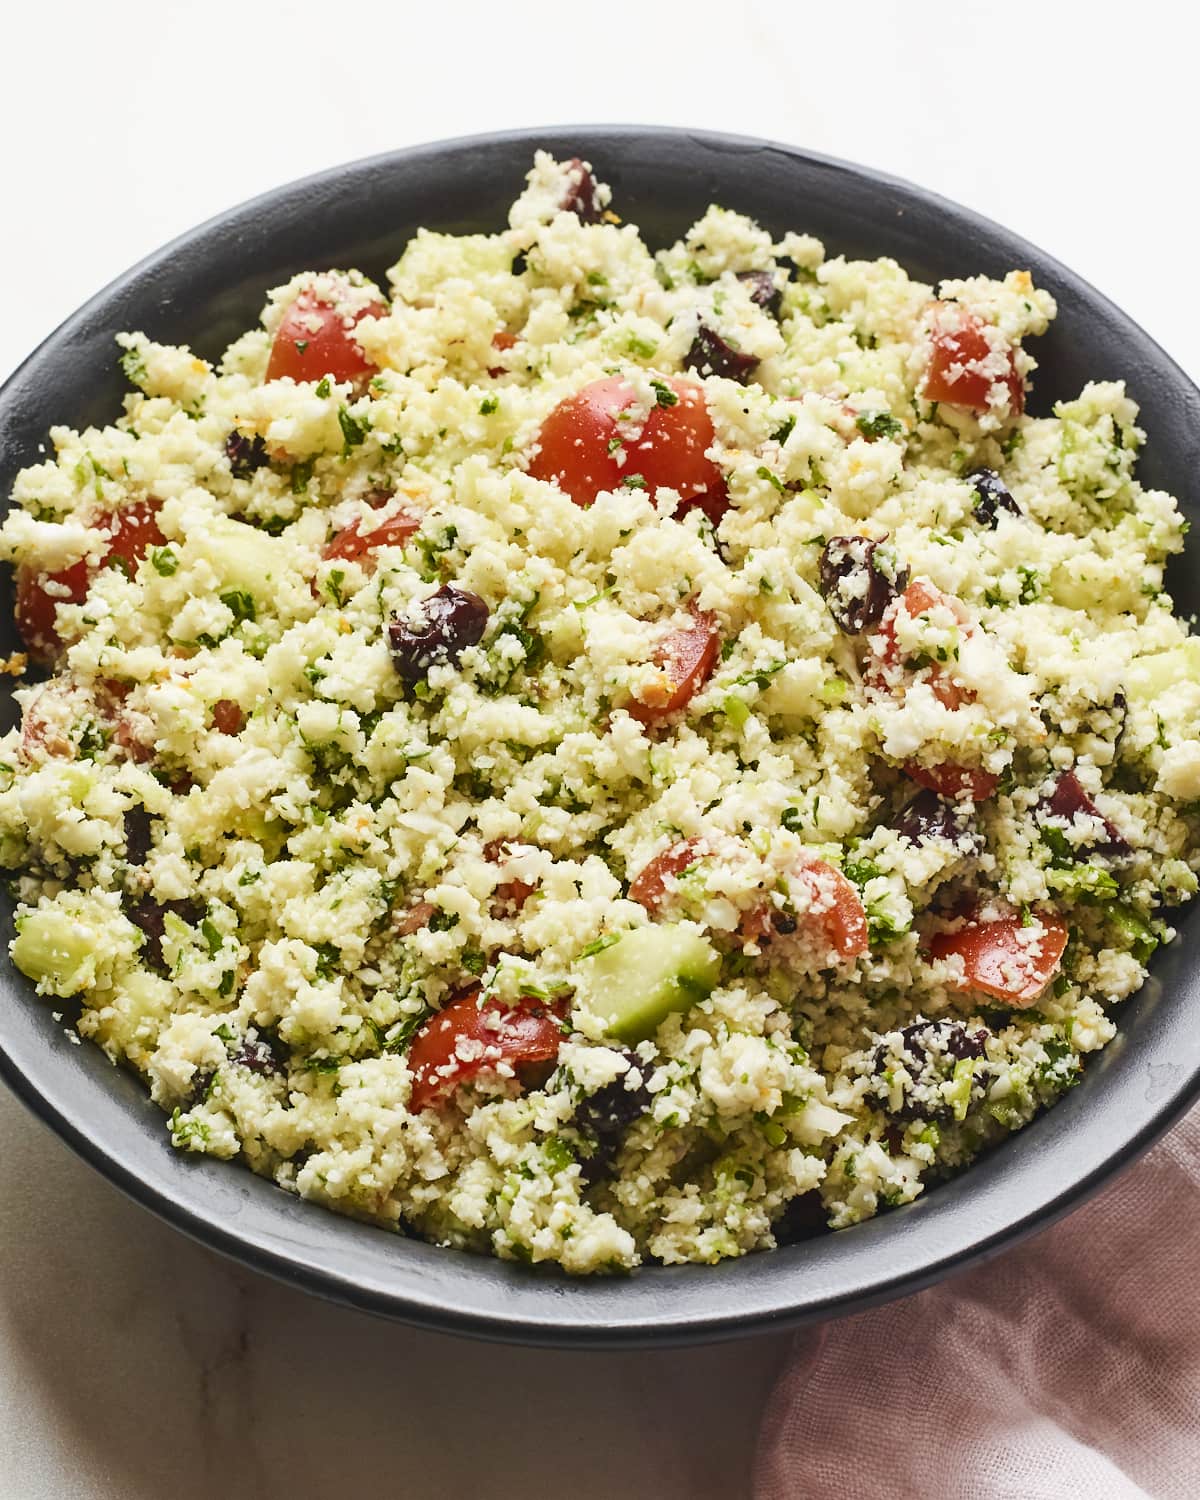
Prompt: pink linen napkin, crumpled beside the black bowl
<box><xmin>755</xmin><ymin>1110</ymin><xmax>1200</xmax><ymax>1500</ymax></box>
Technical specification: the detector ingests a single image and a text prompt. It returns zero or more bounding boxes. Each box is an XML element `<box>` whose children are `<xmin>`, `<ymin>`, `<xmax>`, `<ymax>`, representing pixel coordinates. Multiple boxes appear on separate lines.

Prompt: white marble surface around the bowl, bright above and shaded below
<box><xmin>0</xmin><ymin>0</ymin><xmax>1200</xmax><ymax>1500</ymax></box>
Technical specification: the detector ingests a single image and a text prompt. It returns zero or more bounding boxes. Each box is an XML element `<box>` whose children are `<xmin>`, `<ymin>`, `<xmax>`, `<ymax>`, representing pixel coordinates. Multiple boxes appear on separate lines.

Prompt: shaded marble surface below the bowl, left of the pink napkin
<box><xmin>0</xmin><ymin>1095</ymin><xmax>786</xmax><ymax>1500</ymax></box>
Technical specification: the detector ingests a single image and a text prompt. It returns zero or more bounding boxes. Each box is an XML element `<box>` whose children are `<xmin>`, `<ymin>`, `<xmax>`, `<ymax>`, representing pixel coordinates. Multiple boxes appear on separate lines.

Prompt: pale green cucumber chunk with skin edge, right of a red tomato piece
<box><xmin>575</xmin><ymin>923</ymin><xmax>722</xmax><ymax>1043</ymax></box>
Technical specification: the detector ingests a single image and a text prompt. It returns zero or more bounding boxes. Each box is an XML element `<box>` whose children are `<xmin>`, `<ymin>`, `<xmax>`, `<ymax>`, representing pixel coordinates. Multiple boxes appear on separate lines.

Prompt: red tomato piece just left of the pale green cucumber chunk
<box><xmin>408</xmin><ymin>986</ymin><xmax>563</xmax><ymax>1110</ymax></box>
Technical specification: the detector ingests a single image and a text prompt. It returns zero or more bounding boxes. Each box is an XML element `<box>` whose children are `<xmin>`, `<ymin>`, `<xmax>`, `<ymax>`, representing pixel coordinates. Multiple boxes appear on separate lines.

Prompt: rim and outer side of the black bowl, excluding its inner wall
<box><xmin>0</xmin><ymin>125</ymin><xmax>1200</xmax><ymax>1347</ymax></box>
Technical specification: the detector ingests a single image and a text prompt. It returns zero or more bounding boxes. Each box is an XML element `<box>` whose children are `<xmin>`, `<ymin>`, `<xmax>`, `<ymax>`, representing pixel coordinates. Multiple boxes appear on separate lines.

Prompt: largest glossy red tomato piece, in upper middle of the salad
<box><xmin>530</xmin><ymin>375</ymin><xmax>729</xmax><ymax>525</ymax></box>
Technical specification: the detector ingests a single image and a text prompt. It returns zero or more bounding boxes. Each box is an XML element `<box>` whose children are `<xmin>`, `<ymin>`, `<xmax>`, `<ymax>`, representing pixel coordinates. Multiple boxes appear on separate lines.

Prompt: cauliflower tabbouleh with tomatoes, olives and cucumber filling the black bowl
<box><xmin>0</xmin><ymin>155</ymin><xmax>1200</xmax><ymax>1272</ymax></box>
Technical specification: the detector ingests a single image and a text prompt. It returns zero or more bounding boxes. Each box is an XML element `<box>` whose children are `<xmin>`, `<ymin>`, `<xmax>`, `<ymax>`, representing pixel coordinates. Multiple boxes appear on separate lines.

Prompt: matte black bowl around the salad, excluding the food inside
<box><xmin>0</xmin><ymin>126</ymin><xmax>1200</xmax><ymax>1346</ymax></box>
